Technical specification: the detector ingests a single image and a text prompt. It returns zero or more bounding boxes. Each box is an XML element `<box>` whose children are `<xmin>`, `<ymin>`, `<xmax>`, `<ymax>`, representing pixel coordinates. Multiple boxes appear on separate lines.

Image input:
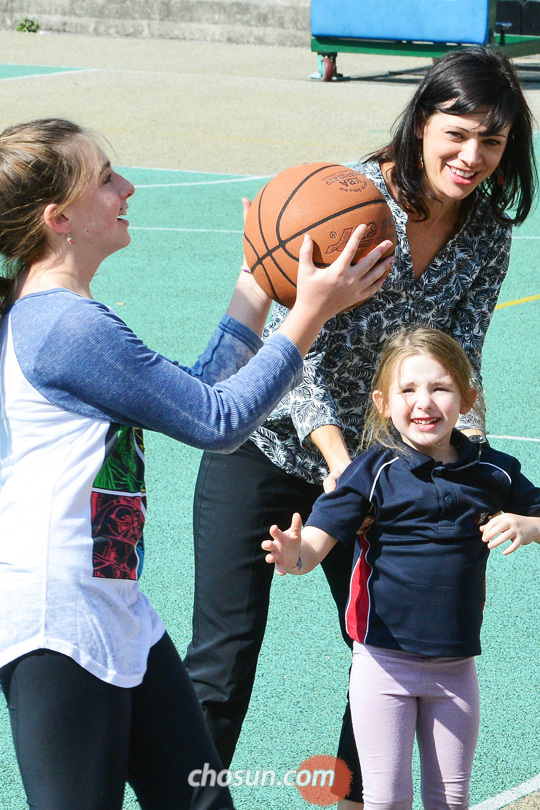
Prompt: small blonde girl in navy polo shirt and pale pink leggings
<box><xmin>262</xmin><ymin>327</ymin><xmax>540</xmax><ymax>810</ymax></box>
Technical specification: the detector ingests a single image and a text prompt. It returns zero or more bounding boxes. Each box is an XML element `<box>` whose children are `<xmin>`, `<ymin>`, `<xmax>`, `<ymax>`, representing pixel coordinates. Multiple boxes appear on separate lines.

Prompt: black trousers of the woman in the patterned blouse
<box><xmin>185</xmin><ymin>441</ymin><xmax>362</xmax><ymax>801</ymax></box>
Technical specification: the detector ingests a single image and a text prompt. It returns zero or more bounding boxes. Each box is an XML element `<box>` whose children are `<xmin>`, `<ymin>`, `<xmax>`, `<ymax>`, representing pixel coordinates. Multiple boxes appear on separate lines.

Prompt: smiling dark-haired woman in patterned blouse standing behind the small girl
<box><xmin>186</xmin><ymin>47</ymin><xmax>536</xmax><ymax>808</ymax></box>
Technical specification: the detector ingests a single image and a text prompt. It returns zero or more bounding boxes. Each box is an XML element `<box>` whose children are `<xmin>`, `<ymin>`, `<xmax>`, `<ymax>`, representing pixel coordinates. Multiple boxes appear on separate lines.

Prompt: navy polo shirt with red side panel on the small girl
<box><xmin>306</xmin><ymin>431</ymin><xmax>540</xmax><ymax>656</ymax></box>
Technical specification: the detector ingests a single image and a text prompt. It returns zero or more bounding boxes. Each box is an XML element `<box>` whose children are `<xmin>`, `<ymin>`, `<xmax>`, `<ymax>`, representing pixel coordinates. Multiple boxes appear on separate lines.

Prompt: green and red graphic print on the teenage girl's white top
<box><xmin>91</xmin><ymin>425</ymin><xmax>146</xmax><ymax>579</ymax></box>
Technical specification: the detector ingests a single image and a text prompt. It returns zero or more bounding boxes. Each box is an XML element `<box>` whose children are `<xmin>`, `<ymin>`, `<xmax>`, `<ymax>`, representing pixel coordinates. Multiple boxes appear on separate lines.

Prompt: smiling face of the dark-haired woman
<box><xmin>417</xmin><ymin>112</ymin><xmax>510</xmax><ymax>211</ymax></box>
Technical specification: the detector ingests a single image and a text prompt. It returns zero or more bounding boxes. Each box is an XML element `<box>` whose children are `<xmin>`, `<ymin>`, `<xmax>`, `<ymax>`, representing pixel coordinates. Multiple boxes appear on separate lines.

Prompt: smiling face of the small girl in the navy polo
<box><xmin>373</xmin><ymin>354</ymin><xmax>476</xmax><ymax>462</ymax></box>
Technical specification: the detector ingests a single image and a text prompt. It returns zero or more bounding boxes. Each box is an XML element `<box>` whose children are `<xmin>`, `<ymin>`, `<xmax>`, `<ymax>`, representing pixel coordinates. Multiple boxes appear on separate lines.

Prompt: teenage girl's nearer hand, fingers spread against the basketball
<box><xmin>295</xmin><ymin>225</ymin><xmax>394</xmax><ymax>320</ymax></box>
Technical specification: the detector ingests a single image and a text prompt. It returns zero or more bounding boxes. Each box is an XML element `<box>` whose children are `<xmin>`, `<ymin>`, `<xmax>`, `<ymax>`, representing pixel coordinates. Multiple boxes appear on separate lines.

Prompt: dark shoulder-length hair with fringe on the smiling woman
<box><xmin>368</xmin><ymin>46</ymin><xmax>537</xmax><ymax>225</ymax></box>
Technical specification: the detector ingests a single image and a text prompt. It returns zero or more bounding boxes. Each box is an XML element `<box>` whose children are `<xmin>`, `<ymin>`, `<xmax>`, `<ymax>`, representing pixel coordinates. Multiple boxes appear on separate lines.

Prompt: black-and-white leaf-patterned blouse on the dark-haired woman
<box><xmin>251</xmin><ymin>161</ymin><xmax>511</xmax><ymax>483</ymax></box>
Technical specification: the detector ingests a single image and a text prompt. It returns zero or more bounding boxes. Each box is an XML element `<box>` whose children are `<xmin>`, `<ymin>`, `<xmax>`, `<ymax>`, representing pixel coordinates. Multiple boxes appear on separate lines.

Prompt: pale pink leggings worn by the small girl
<box><xmin>350</xmin><ymin>642</ymin><xmax>479</xmax><ymax>810</ymax></box>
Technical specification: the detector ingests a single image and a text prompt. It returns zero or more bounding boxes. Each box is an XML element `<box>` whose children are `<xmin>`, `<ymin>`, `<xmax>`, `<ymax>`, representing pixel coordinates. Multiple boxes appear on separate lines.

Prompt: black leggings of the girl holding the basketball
<box><xmin>0</xmin><ymin>635</ymin><xmax>233</xmax><ymax>810</ymax></box>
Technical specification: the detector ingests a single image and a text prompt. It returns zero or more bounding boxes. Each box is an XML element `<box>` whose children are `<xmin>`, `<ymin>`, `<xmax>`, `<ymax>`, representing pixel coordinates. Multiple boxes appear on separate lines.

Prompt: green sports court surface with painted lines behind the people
<box><xmin>0</xmin><ymin>60</ymin><xmax>540</xmax><ymax>810</ymax></box>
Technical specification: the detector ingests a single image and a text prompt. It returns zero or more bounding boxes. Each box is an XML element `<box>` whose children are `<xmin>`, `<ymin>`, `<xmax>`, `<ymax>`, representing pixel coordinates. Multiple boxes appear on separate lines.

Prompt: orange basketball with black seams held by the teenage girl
<box><xmin>244</xmin><ymin>163</ymin><xmax>396</xmax><ymax>308</ymax></box>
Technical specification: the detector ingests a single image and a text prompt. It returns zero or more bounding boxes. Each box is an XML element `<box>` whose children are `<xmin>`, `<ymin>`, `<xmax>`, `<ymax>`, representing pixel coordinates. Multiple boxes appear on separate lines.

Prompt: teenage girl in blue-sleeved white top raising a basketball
<box><xmin>0</xmin><ymin>119</ymin><xmax>391</xmax><ymax>810</ymax></box>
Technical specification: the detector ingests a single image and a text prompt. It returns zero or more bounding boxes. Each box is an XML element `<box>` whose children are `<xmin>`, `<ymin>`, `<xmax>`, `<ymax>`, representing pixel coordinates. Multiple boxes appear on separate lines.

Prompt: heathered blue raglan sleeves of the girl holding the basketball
<box><xmin>11</xmin><ymin>294</ymin><xmax>302</xmax><ymax>452</ymax></box>
